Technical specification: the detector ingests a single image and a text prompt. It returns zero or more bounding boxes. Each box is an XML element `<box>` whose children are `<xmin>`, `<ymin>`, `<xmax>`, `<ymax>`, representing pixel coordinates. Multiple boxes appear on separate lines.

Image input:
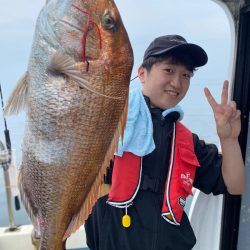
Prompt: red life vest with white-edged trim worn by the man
<box><xmin>107</xmin><ymin>122</ymin><xmax>200</xmax><ymax>225</ymax></box>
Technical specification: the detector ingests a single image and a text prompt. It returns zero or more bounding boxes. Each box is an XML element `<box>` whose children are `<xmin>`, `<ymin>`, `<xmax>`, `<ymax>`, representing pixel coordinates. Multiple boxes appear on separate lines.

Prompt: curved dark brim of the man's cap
<box><xmin>151</xmin><ymin>43</ymin><xmax>208</xmax><ymax>67</ymax></box>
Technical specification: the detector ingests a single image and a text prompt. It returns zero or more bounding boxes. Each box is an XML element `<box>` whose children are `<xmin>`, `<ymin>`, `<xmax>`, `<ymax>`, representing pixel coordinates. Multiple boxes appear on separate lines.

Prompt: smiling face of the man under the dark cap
<box><xmin>138</xmin><ymin>61</ymin><xmax>193</xmax><ymax>109</ymax></box>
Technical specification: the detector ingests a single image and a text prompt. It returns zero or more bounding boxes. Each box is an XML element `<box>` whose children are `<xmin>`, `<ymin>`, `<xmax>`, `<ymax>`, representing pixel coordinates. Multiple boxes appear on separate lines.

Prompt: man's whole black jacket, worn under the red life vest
<box><xmin>85</xmin><ymin>97</ymin><xmax>226</xmax><ymax>250</ymax></box>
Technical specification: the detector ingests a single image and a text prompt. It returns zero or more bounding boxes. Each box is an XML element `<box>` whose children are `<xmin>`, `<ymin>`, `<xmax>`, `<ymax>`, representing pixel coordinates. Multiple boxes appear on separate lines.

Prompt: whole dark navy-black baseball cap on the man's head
<box><xmin>143</xmin><ymin>35</ymin><xmax>208</xmax><ymax>67</ymax></box>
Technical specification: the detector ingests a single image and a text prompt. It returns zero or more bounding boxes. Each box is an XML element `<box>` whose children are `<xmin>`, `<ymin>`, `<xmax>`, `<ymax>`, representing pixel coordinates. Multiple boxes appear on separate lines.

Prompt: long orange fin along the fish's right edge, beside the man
<box><xmin>63</xmin><ymin>96</ymin><xmax>128</xmax><ymax>241</ymax></box>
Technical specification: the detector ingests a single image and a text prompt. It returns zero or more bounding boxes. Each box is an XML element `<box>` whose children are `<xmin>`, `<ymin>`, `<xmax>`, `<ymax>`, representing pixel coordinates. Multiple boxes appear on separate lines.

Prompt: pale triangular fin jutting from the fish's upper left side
<box><xmin>4</xmin><ymin>71</ymin><xmax>28</xmax><ymax>116</ymax></box>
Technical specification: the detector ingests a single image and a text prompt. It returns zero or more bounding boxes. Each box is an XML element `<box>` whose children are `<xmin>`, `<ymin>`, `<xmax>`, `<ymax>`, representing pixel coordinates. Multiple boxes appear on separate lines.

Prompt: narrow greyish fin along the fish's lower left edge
<box><xmin>18</xmin><ymin>167</ymin><xmax>40</xmax><ymax>233</ymax></box>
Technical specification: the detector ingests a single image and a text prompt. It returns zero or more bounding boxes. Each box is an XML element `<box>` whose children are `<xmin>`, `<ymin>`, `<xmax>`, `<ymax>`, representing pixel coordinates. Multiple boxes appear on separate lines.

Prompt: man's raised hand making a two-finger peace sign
<box><xmin>204</xmin><ymin>81</ymin><xmax>241</xmax><ymax>140</ymax></box>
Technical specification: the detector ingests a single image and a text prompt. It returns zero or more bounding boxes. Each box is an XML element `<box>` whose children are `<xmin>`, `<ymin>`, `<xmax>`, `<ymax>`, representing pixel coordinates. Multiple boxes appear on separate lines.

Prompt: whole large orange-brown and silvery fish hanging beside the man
<box><xmin>5</xmin><ymin>0</ymin><xmax>133</xmax><ymax>250</ymax></box>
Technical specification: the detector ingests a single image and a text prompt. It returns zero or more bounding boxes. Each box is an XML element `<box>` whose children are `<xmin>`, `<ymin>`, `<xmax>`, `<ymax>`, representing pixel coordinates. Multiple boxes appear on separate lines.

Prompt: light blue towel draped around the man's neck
<box><xmin>116</xmin><ymin>87</ymin><xmax>183</xmax><ymax>156</ymax></box>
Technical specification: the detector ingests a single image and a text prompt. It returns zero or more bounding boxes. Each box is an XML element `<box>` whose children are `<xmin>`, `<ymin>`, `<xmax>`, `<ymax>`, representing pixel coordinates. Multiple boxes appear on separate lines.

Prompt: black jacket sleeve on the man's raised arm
<box><xmin>193</xmin><ymin>134</ymin><xmax>227</xmax><ymax>195</ymax></box>
